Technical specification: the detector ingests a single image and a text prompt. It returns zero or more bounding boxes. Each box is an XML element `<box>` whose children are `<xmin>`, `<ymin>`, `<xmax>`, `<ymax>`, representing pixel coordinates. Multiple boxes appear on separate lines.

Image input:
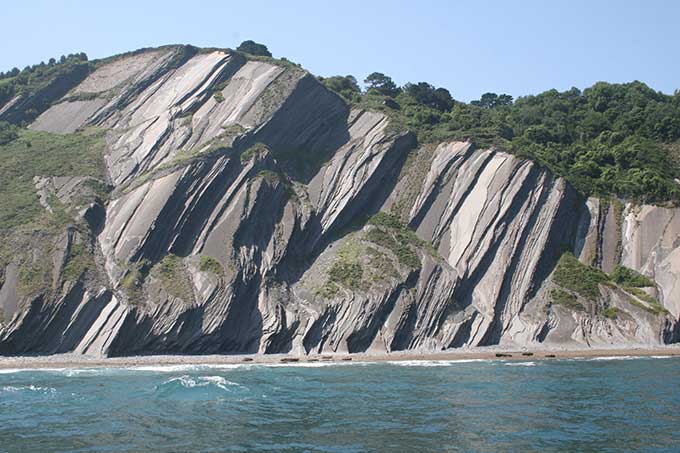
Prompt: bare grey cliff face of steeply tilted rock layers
<box><xmin>0</xmin><ymin>47</ymin><xmax>680</xmax><ymax>355</ymax></box>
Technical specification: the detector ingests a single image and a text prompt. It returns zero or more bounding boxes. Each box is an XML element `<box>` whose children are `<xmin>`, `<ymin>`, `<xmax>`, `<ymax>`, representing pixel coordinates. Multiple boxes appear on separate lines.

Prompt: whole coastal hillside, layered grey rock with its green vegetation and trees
<box><xmin>0</xmin><ymin>46</ymin><xmax>680</xmax><ymax>355</ymax></box>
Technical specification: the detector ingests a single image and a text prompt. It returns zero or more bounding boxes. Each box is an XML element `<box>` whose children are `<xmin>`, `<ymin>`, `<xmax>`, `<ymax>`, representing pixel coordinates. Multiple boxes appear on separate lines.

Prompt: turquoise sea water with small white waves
<box><xmin>0</xmin><ymin>358</ymin><xmax>680</xmax><ymax>452</ymax></box>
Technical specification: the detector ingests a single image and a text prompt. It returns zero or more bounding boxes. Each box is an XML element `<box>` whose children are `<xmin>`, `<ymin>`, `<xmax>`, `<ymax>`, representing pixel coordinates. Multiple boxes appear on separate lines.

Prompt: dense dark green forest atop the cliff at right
<box><xmin>320</xmin><ymin>73</ymin><xmax>680</xmax><ymax>203</ymax></box>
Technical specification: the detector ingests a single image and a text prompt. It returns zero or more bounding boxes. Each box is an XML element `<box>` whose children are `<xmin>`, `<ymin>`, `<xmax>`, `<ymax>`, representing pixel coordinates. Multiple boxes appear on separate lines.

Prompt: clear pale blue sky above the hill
<box><xmin>0</xmin><ymin>0</ymin><xmax>680</xmax><ymax>101</ymax></box>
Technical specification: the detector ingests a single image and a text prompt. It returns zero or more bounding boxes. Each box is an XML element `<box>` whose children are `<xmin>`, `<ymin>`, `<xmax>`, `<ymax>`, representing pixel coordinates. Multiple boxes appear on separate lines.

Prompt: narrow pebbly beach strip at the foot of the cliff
<box><xmin>0</xmin><ymin>344</ymin><xmax>680</xmax><ymax>370</ymax></box>
